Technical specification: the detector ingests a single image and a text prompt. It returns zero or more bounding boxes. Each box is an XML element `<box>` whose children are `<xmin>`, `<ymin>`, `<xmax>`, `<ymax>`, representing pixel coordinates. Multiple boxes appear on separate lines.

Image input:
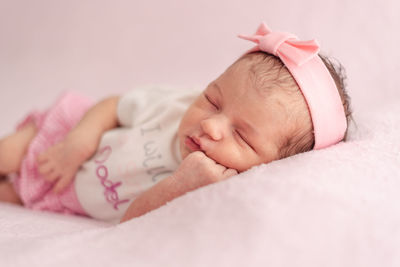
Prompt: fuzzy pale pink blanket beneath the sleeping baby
<box><xmin>0</xmin><ymin>105</ymin><xmax>400</xmax><ymax>267</ymax></box>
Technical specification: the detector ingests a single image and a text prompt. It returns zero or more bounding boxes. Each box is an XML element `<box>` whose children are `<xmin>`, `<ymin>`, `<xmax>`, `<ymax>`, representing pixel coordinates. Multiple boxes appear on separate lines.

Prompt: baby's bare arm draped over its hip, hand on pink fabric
<box><xmin>37</xmin><ymin>96</ymin><xmax>119</xmax><ymax>193</ymax></box>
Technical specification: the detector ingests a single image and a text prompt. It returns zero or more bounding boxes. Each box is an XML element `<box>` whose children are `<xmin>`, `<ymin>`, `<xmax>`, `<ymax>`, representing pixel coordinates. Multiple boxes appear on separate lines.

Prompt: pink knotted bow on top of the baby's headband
<box><xmin>238</xmin><ymin>22</ymin><xmax>319</xmax><ymax>66</ymax></box>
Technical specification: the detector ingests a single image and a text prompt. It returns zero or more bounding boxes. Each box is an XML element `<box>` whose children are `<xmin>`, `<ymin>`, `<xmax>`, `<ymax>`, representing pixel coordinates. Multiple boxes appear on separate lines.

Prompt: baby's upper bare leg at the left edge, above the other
<box><xmin>0</xmin><ymin>122</ymin><xmax>37</xmax><ymax>176</ymax></box>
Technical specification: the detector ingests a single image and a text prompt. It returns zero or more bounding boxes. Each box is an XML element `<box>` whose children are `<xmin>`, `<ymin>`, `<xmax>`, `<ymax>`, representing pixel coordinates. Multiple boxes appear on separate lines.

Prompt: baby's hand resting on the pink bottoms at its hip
<box><xmin>37</xmin><ymin>137</ymin><xmax>88</xmax><ymax>193</ymax></box>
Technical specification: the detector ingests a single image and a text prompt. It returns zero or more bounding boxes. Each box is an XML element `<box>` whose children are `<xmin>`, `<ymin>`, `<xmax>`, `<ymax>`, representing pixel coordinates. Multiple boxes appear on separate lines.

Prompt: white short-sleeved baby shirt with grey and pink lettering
<box><xmin>74</xmin><ymin>87</ymin><xmax>200</xmax><ymax>222</ymax></box>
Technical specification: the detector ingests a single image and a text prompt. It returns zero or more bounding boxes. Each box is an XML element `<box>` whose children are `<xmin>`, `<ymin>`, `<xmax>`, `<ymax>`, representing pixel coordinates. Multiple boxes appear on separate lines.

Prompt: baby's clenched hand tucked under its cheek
<box><xmin>174</xmin><ymin>151</ymin><xmax>238</xmax><ymax>191</ymax></box>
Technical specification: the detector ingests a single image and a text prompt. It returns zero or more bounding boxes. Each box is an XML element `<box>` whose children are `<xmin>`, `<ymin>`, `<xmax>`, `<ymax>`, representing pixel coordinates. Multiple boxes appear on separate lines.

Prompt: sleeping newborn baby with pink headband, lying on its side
<box><xmin>0</xmin><ymin>24</ymin><xmax>350</xmax><ymax>224</ymax></box>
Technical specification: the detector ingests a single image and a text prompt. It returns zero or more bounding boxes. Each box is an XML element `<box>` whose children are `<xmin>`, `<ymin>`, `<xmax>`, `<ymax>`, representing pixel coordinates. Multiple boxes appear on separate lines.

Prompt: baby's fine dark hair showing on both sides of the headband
<box><xmin>233</xmin><ymin>51</ymin><xmax>352</xmax><ymax>159</ymax></box>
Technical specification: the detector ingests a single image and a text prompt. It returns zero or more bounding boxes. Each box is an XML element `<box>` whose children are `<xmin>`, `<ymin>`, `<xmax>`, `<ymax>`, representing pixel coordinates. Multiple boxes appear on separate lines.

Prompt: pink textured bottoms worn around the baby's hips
<box><xmin>13</xmin><ymin>92</ymin><xmax>92</xmax><ymax>218</ymax></box>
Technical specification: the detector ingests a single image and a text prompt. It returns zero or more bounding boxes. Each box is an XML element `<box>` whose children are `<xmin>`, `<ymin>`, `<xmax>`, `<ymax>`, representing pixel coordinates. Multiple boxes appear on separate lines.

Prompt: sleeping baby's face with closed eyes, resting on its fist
<box><xmin>178</xmin><ymin>61</ymin><xmax>288</xmax><ymax>172</ymax></box>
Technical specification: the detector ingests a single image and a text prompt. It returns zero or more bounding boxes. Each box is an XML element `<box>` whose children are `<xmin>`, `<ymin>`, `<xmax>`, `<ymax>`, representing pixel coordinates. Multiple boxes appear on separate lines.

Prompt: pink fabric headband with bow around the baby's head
<box><xmin>239</xmin><ymin>23</ymin><xmax>347</xmax><ymax>149</ymax></box>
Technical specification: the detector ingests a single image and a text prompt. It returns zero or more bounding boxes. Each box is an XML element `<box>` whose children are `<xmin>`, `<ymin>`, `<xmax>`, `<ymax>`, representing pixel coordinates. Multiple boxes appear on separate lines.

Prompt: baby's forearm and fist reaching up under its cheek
<box><xmin>121</xmin><ymin>151</ymin><xmax>237</xmax><ymax>222</ymax></box>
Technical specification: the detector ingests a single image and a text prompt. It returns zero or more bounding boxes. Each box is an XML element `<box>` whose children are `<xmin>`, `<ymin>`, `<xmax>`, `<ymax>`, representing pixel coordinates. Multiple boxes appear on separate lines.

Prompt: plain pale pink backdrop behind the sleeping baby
<box><xmin>0</xmin><ymin>0</ymin><xmax>400</xmax><ymax>135</ymax></box>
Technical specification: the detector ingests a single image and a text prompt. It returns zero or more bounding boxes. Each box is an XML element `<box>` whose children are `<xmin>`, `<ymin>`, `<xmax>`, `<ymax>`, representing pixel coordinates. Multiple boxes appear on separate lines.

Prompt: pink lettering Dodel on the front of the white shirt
<box><xmin>94</xmin><ymin>146</ymin><xmax>129</xmax><ymax>210</ymax></box>
